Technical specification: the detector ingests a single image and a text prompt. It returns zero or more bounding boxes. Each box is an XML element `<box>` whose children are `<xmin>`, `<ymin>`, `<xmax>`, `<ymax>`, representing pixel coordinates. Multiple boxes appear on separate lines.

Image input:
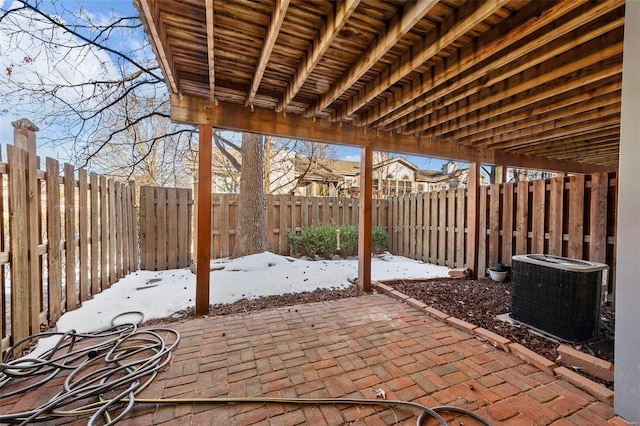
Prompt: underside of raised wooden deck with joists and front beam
<box><xmin>134</xmin><ymin>0</ymin><xmax>624</xmax><ymax>172</ymax></box>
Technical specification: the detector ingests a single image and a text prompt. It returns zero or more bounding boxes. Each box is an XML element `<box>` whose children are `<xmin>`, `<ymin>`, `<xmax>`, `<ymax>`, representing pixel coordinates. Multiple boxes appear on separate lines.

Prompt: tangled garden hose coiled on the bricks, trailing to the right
<box><xmin>0</xmin><ymin>313</ymin><xmax>490</xmax><ymax>426</ymax></box>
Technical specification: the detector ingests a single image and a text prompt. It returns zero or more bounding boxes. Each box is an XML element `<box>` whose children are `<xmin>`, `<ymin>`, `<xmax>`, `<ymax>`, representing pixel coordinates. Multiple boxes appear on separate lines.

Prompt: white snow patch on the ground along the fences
<box><xmin>31</xmin><ymin>252</ymin><xmax>449</xmax><ymax>356</ymax></box>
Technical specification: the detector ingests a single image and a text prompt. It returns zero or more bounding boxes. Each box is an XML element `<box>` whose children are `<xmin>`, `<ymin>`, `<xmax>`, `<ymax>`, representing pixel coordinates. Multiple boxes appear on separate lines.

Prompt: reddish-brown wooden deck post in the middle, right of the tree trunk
<box><xmin>358</xmin><ymin>145</ymin><xmax>373</xmax><ymax>293</ymax></box>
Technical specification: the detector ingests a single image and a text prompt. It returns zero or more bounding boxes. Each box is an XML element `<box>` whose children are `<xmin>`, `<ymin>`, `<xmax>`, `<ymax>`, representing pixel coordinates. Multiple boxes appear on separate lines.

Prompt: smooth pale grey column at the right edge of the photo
<box><xmin>614</xmin><ymin>1</ymin><xmax>640</xmax><ymax>424</ymax></box>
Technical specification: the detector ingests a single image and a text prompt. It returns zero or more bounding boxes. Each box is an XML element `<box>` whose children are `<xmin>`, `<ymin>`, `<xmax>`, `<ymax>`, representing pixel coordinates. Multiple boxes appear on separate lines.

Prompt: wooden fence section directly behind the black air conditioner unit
<box><xmin>477</xmin><ymin>173</ymin><xmax>617</xmax><ymax>291</ymax></box>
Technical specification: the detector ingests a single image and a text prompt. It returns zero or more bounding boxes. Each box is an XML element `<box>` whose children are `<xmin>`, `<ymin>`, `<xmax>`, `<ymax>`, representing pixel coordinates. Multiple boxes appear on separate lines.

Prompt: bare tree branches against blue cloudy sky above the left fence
<box><xmin>0</xmin><ymin>1</ymin><xmax>194</xmax><ymax>181</ymax></box>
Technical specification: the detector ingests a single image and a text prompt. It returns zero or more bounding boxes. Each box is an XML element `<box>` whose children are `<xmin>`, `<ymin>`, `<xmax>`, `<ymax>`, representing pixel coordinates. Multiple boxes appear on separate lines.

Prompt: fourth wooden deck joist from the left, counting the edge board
<box><xmin>276</xmin><ymin>0</ymin><xmax>361</xmax><ymax>112</ymax></box>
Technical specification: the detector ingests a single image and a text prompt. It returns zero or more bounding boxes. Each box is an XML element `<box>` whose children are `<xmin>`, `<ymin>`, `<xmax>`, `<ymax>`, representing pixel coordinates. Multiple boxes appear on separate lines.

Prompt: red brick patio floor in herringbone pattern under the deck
<box><xmin>0</xmin><ymin>294</ymin><xmax>628</xmax><ymax>426</ymax></box>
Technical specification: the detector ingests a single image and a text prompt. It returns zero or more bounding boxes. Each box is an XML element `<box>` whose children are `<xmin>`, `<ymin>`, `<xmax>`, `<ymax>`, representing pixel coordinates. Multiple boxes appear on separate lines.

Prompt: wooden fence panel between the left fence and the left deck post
<box><xmin>140</xmin><ymin>186</ymin><xmax>193</xmax><ymax>271</ymax></box>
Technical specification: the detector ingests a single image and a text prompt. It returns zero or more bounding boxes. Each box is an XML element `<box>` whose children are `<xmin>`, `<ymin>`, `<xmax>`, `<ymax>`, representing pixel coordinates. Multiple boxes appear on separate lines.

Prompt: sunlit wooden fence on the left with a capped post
<box><xmin>0</xmin><ymin>122</ymin><xmax>138</xmax><ymax>351</ymax></box>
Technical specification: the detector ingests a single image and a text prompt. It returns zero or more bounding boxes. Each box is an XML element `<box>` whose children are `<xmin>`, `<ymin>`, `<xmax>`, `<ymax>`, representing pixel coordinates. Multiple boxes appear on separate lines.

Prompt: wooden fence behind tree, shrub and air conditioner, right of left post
<box><xmin>191</xmin><ymin>173</ymin><xmax>617</xmax><ymax>290</ymax></box>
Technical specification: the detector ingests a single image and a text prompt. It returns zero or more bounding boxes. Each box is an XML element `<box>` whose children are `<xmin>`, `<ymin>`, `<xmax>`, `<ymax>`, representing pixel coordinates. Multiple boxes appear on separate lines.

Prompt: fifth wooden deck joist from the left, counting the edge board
<box><xmin>306</xmin><ymin>0</ymin><xmax>438</xmax><ymax>117</ymax></box>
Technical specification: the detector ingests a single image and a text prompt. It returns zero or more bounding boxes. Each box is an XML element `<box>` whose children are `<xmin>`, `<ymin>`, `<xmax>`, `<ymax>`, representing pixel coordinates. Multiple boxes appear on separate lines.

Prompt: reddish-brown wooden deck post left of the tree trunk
<box><xmin>196</xmin><ymin>124</ymin><xmax>213</xmax><ymax>315</ymax></box>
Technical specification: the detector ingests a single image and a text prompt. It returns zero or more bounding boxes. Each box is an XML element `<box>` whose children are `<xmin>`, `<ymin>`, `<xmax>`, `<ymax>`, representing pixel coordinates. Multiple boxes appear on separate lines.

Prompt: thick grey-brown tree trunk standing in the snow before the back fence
<box><xmin>231</xmin><ymin>133</ymin><xmax>267</xmax><ymax>258</ymax></box>
